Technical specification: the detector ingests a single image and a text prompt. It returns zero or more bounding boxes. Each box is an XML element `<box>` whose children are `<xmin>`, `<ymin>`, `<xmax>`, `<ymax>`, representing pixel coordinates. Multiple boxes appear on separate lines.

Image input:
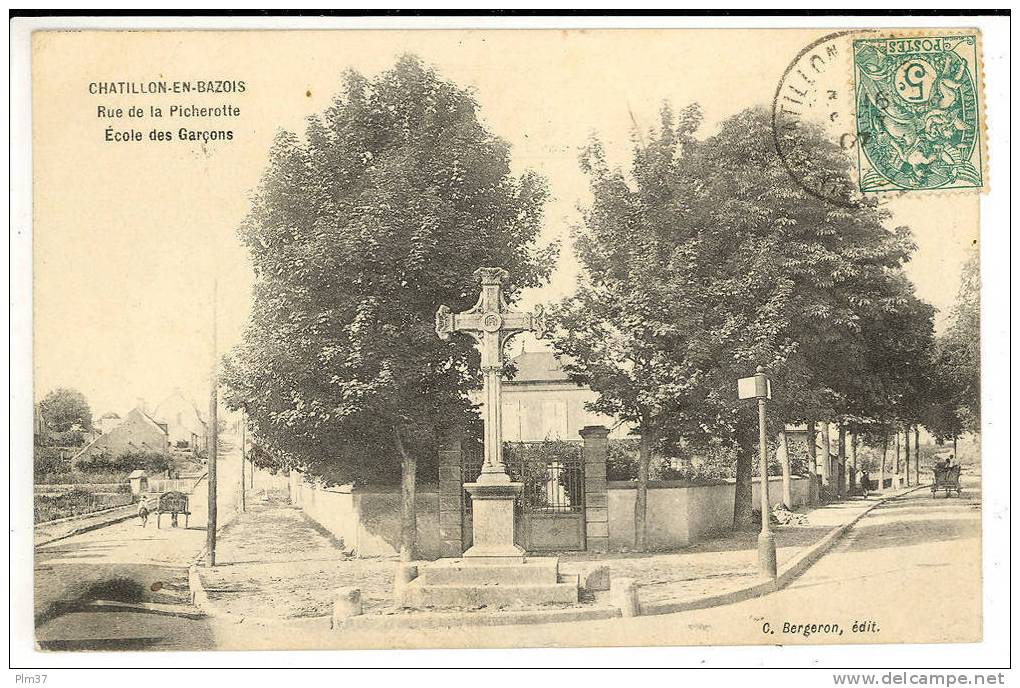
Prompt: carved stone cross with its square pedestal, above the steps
<box><xmin>436</xmin><ymin>268</ymin><xmax>546</xmax><ymax>559</ymax></box>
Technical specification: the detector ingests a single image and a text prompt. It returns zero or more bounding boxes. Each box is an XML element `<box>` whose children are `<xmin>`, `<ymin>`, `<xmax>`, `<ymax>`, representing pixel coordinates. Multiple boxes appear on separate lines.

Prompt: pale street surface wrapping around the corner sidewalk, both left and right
<box><xmin>37</xmin><ymin>478</ymin><xmax>981</xmax><ymax>649</ymax></box>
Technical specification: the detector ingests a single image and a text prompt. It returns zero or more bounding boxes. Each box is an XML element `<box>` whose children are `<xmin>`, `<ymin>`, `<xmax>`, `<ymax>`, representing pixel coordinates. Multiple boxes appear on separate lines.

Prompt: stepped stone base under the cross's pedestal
<box><xmin>401</xmin><ymin>557</ymin><xmax>578</xmax><ymax>608</ymax></box>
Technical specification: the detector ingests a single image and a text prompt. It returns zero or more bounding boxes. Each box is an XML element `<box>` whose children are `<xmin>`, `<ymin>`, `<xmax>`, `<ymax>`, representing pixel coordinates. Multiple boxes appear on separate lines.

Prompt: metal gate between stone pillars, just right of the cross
<box><xmin>504</xmin><ymin>441</ymin><xmax>585</xmax><ymax>551</ymax></box>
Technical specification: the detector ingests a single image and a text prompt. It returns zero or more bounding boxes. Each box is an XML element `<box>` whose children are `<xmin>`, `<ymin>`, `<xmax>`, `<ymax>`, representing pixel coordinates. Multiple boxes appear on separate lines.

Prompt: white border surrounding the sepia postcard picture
<box><xmin>7</xmin><ymin>16</ymin><xmax>1020</xmax><ymax>676</ymax></box>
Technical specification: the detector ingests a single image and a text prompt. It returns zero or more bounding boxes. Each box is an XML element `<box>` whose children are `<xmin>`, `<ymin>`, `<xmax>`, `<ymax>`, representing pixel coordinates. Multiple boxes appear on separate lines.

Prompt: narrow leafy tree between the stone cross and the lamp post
<box><xmin>553</xmin><ymin>106</ymin><xmax>701</xmax><ymax>551</ymax></box>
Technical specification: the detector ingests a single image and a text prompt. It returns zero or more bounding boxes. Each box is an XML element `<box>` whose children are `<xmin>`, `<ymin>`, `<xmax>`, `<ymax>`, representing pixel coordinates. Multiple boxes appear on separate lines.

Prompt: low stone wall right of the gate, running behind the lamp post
<box><xmin>609</xmin><ymin>477</ymin><xmax>818</xmax><ymax>549</ymax></box>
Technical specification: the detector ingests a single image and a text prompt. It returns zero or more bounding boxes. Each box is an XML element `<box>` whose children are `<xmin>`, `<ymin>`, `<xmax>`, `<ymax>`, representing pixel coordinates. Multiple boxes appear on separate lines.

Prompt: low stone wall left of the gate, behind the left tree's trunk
<box><xmin>291</xmin><ymin>471</ymin><xmax>441</xmax><ymax>559</ymax></box>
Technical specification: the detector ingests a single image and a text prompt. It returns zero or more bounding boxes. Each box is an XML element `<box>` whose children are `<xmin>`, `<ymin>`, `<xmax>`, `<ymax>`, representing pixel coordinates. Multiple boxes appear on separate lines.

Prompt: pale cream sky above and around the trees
<box><xmin>33</xmin><ymin>30</ymin><xmax>977</xmax><ymax>416</ymax></box>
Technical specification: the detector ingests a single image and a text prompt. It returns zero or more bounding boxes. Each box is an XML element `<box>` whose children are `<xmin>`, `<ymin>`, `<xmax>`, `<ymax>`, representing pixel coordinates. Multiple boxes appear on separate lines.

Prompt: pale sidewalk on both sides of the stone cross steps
<box><xmin>189</xmin><ymin>488</ymin><xmax>915</xmax><ymax>621</ymax></box>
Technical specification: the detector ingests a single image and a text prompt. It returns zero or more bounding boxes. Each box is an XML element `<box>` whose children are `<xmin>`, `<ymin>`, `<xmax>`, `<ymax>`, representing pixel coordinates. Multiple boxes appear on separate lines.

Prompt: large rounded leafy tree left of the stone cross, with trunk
<box><xmin>224</xmin><ymin>56</ymin><xmax>555</xmax><ymax>558</ymax></box>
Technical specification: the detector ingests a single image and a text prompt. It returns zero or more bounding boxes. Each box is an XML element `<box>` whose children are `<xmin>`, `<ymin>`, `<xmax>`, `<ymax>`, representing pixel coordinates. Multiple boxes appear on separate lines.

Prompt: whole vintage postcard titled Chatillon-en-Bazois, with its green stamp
<box><xmin>11</xmin><ymin>17</ymin><xmax>1008</xmax><ymax>668</ymax></box>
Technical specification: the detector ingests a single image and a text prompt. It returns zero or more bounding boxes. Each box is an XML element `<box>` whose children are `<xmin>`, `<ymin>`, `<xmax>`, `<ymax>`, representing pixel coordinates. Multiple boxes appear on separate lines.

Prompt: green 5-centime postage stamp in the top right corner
<box><xmin>854</xmin><ymin>32</ymin><xmax>987</xmax><ymax>192</ymax></box>
